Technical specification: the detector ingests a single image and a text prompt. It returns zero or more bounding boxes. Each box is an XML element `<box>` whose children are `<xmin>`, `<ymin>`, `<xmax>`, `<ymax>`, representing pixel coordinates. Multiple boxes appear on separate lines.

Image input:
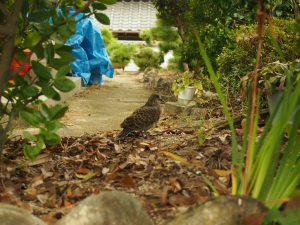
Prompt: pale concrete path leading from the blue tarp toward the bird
<box><xmin>13</xmin><ymin>75</ymin><xmax>151</xmax><ymax>136</ymax></box>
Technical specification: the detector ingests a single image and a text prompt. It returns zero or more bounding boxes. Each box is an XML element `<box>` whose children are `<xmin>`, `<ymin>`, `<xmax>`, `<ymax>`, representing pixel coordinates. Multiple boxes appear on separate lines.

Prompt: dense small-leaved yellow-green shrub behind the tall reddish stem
<box><xmin>217</xmin><ymin>18</ymin><xmax>300</xmax><ymax>95</ymax></box>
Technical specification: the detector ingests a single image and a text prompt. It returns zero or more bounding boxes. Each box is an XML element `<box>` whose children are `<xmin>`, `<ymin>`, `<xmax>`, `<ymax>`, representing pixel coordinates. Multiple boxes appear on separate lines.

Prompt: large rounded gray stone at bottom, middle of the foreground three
<box><xmin>57</xmin><ymin>191</ymin><xmax>152</xmax><ymax>225</ymax></box>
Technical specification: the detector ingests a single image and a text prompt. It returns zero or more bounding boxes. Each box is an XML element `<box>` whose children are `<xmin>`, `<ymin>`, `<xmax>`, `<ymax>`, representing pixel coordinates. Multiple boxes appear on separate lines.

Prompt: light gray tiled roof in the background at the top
<box><xmin>99</xmin><ymin>0</ymin><xmax>157</xmax><ymax>32</ymax></box>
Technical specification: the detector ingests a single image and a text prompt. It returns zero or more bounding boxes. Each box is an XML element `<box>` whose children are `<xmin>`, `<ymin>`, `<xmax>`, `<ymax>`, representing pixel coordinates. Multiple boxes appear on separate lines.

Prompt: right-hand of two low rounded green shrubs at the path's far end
<box><xmin>133</xmin><ymin>48</ymin><xmax>164</xmax><ymax>70</ymax></box>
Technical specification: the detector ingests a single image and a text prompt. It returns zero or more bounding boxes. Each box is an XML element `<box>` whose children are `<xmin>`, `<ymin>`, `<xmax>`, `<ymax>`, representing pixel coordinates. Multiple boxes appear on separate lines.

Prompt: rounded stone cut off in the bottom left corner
<box><xmin>0</xmin><ymin>203</ymin><xmax>47</xmax><ymax>225</ymax></box>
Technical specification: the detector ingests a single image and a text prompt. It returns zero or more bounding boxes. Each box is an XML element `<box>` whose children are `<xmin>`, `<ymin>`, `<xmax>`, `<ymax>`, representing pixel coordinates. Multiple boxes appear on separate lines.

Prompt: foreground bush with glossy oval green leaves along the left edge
<box><xmin>0</xmin><ymin>0</ymin><xmax>116</xmax><ymax>161</ymax></box>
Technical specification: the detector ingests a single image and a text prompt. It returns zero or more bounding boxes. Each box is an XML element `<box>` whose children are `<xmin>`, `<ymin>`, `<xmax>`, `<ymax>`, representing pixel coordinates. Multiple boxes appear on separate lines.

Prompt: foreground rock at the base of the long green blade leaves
<box><xmin>163</xmin><ymin>196</ymin><xmax>267</xmax><ymax>225</ymax></box>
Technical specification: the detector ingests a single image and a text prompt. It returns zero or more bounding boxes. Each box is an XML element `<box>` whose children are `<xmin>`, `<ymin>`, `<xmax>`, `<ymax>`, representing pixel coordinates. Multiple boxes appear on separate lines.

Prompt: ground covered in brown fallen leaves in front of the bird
<box><xmin>0</xmin><ymin>117</ymin><xmax>246</xmax><ymax>224</ymax></box>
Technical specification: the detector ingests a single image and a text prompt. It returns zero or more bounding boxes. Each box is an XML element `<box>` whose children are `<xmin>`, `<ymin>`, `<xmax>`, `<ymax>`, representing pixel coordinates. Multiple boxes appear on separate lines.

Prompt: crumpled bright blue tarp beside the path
<box><xmin>66</xmin><ymin>9</ymin><xmax>114</xmax><ymax>85</ymax></box>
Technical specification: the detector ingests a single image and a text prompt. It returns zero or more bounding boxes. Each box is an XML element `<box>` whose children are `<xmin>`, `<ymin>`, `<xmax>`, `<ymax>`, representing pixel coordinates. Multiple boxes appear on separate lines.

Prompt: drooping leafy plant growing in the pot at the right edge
<box><xmin>239</xmin><ymin>60</ymin><xmax>300</xmax><ymax>122</ymax></box>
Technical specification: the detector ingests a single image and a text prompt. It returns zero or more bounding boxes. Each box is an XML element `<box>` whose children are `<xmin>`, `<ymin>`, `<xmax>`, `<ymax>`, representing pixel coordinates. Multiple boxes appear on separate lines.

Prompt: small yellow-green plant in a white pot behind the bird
<box><xmin>172</xmin><ymin>71</ymin><xmax>203</xmax><ymax>105</ymax></box>
